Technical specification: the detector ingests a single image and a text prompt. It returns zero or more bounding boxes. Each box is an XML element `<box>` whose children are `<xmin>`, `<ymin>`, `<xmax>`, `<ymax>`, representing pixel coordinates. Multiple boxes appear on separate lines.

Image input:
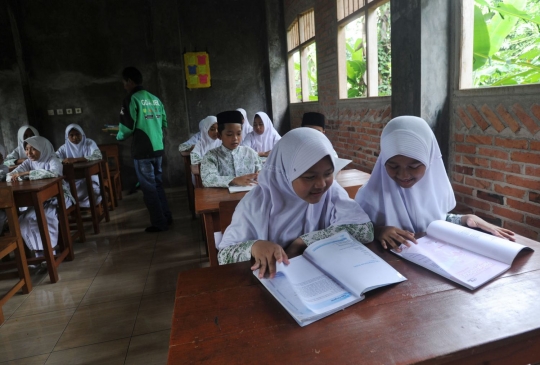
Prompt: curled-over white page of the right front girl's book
<box><xmin>426</xmin><ymin>220</ymin><xmax>526</xmax><ymax>265</ymax></box>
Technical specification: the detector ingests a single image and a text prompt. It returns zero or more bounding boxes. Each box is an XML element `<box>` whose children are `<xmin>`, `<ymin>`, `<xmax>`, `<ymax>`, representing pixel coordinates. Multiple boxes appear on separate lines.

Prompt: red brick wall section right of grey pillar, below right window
<box><xmin>451</xmin><ymin>102</ymin><xmax>540</xmax><ymax>240</ymax></box>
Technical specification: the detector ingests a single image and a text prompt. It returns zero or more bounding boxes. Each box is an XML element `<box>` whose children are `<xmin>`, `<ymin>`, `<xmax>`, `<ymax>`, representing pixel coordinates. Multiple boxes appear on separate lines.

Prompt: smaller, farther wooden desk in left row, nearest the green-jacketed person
<box><xmin>73</xmin><ymin>160</ymin><xmax>111</xmax><ymax>234</ymax></box>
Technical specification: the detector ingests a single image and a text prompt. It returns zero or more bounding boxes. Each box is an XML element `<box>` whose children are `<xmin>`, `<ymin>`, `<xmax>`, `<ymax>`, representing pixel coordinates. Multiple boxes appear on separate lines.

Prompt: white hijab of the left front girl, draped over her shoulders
<box><xmin>218</xmin><ymin>128</ymin><xmax>369</xmax><ymax>249</ymax></box>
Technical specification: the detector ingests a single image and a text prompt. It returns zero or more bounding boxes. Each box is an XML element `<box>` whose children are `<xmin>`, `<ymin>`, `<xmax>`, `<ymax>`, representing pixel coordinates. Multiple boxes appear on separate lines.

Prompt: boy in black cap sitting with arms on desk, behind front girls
<box><xmin>201</xmin><ymin>110</ymin><xmax>261</xmax><ymax>188</ymax></box>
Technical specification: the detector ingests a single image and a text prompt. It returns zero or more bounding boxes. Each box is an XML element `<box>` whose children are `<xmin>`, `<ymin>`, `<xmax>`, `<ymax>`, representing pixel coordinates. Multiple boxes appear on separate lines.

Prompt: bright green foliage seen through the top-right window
<box><xmin>473</xmin><ymin>0</ymin><xmax>540</xmax><ymax>87</ymax></box>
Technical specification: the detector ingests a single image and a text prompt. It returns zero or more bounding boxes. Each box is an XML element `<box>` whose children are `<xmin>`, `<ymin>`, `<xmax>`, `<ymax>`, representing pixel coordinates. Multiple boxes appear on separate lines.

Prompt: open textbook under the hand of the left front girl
<box><xmin>253</xmin><ymin>231</ymin><xmax>407</xmax><ymax>327</ymax></box>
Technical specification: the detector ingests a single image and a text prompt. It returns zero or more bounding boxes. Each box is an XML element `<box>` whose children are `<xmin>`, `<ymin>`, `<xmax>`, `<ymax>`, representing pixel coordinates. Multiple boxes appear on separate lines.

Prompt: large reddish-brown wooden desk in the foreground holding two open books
<box><xmin>168</xmin><ymin>238</ymin><xmax>540</xmax><ymax>365</ymax></box>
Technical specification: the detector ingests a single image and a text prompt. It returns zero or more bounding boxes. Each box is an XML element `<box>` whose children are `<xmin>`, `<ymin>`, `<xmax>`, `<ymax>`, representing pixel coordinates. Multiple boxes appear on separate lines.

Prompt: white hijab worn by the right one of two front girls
<box><xmin>355</xmin><ymin>116</ymin><xmax>456</xmax><ymax>232</ymax></box>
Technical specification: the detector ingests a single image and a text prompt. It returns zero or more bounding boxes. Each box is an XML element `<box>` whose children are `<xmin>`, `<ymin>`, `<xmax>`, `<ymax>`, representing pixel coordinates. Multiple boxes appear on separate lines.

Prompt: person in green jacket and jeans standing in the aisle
<box><xmin>116</xmin><ymin>67</ymin><xmax>172</xmax><ymax>232</ymax></box>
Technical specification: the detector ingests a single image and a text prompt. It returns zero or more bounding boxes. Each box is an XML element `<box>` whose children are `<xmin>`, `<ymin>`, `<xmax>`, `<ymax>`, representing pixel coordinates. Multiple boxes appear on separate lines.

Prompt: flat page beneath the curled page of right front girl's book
<box><xmin>392</xmin><ymin>236</ymin><xmax>510</xmax><ymax>289</ymax></box>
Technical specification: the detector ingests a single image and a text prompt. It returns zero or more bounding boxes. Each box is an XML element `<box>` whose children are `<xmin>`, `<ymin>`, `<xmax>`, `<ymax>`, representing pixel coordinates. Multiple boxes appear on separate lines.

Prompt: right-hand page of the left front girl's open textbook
<box><xmin>304</xmin><ymin>231</ymin><xmax>407</xmax><ymax>296</ymax></box>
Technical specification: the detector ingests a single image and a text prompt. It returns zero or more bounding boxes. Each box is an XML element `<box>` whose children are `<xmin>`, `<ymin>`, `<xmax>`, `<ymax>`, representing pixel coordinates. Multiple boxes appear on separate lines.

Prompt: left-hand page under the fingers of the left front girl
<box><xmin>253</xmin><ymin>256</ymin><xmax>362</xmax><ymax>321</ymax></box>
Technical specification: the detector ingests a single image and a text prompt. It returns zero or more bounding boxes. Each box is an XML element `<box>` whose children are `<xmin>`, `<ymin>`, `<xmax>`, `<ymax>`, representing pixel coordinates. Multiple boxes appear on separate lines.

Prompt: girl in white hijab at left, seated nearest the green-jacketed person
<box><xmin>56</xmin><ymin>124</ymin><xmax>102</xmax><ymax>208</ymax></box>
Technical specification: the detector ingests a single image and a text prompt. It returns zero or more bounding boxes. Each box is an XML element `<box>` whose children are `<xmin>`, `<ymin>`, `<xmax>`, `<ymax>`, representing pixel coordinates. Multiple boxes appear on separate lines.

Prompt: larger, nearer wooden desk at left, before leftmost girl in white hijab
<box><xmin>1</xmin><ymin>177</ymin><xmax>75</xmax><ymax>283</ymax></box>
